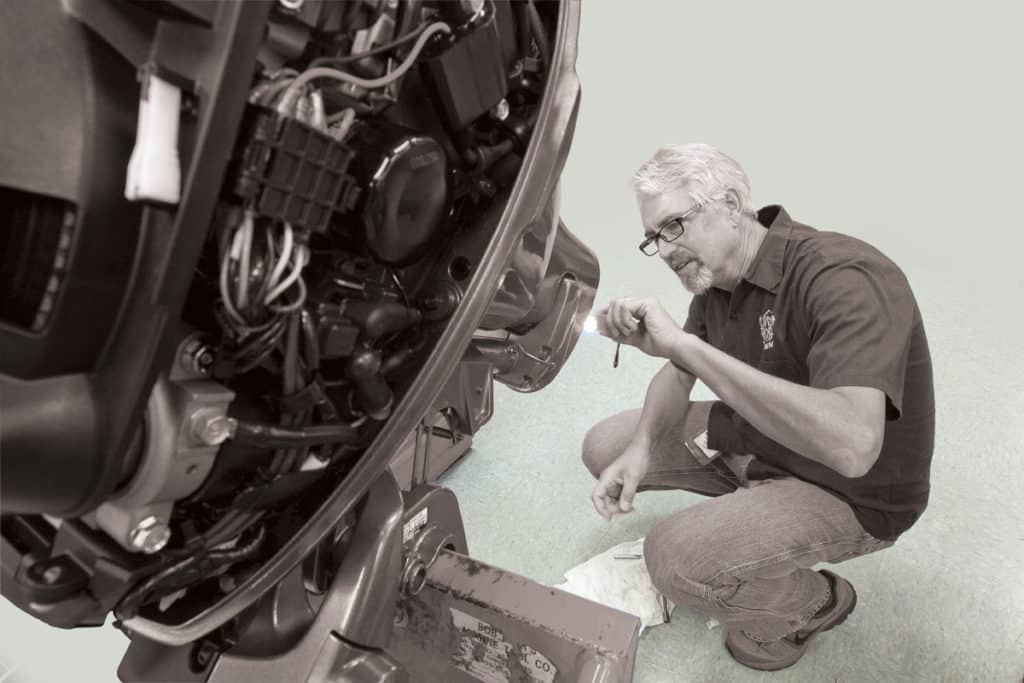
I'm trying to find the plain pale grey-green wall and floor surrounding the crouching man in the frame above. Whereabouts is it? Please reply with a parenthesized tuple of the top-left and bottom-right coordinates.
(0, 0, 1024, 683)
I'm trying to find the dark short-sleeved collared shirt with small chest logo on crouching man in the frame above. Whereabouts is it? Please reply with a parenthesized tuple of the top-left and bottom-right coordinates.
(684, 206, 935, 540)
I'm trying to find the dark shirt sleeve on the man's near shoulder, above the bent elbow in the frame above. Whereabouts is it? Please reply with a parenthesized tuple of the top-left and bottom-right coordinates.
(805, 255, 916, 419)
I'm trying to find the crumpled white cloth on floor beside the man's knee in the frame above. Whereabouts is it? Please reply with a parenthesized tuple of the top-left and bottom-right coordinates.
(555, 538, 675, 633)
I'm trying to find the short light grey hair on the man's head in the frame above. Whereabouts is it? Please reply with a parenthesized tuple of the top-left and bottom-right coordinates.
(633, 142, 756, 215)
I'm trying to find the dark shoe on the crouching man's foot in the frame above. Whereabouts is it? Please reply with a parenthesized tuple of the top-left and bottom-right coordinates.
(725, 569, 857, 671)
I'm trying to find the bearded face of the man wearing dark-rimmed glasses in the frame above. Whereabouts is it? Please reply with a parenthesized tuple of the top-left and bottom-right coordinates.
(639, 186, 736, 294)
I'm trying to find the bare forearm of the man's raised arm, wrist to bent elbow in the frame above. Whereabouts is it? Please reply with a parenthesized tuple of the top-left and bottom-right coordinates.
(667, 331, 886, 478)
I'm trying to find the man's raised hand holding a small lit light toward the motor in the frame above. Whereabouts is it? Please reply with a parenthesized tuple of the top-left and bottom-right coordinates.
(594, 297, 683, 358)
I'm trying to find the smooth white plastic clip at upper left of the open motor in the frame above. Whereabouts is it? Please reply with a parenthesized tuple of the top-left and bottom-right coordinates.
(125, 71, 181, 204)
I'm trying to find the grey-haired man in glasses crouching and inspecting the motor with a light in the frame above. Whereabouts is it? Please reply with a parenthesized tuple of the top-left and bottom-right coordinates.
(583, 143, 934, 671)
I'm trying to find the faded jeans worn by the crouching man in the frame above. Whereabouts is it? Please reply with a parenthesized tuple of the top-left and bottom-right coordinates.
(583, 401, 893, 642)
